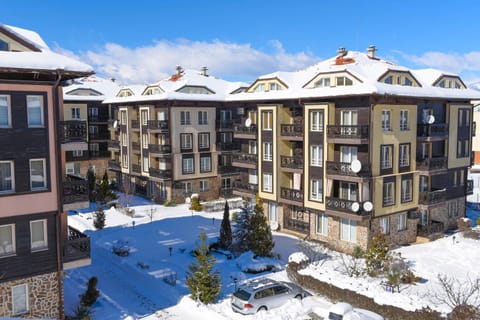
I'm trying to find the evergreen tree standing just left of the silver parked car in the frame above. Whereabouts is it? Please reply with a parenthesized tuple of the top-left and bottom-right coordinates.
(186, 230, 221, 304)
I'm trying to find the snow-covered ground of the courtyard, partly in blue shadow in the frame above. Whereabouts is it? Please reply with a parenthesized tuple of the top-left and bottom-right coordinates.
(65, 198, 480, 320)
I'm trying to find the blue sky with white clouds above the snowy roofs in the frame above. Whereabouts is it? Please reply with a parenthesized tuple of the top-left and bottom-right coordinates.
(0, 0, 480, 83)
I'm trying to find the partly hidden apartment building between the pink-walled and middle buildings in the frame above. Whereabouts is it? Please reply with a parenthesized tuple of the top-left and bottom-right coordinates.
(63, 75, 120, 178)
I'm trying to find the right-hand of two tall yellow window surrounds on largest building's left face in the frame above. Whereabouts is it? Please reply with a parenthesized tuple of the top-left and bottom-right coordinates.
(303, 103, 335, 211)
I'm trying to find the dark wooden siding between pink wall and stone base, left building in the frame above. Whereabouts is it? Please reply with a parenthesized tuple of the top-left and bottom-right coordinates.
(0, 212, 58, 281)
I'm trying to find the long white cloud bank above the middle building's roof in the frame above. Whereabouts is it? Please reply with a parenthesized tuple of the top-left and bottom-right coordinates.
(67, 39, 318, 84)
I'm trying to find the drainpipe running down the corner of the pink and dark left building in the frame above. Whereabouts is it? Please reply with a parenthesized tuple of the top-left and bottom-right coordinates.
(52, 69, 65, 319)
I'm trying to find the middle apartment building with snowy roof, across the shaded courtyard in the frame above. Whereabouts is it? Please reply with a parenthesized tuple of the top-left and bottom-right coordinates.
(104, 66, 248, 203)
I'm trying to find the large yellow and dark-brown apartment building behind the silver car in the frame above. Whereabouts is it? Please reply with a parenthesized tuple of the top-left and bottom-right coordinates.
(228, 46, 479, 252)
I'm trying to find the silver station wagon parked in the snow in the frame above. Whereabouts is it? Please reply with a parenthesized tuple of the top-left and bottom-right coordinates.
(231, 278, 305, 314)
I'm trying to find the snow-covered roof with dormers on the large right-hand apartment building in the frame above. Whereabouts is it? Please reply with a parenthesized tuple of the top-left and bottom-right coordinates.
(227, 51, 480, 101)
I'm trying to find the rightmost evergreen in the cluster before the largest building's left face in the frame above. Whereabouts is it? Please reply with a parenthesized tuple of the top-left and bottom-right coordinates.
(247, 194, 275, 257)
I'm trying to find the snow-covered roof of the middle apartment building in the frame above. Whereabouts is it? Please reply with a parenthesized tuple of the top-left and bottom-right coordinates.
(104, 70, 248, 103)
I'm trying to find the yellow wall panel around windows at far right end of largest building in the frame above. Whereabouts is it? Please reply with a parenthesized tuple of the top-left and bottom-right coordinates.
(447, 104, 473, 168)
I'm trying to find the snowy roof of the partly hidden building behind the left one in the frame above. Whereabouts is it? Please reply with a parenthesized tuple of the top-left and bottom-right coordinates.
(63, 75, 121, 101)
